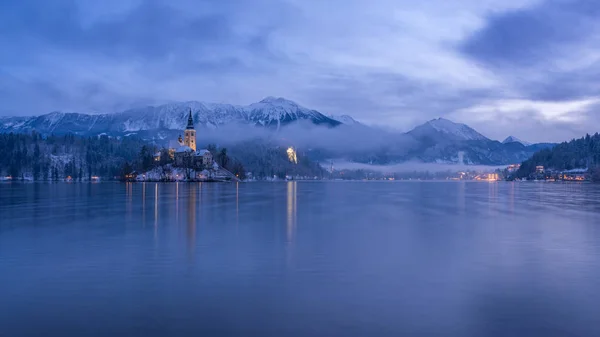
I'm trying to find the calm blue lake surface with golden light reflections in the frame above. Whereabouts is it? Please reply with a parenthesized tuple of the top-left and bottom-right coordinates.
(0, 182, 600, 337)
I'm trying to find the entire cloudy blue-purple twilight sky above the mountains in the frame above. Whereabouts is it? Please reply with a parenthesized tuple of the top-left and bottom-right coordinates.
(0, 0, 600, 141)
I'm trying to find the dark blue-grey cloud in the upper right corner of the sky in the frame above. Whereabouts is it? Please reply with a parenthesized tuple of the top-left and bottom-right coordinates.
(461, 0, 600, 101)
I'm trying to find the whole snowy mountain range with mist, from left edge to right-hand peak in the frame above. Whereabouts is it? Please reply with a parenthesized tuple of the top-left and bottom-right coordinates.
(0, 102, 552, 165)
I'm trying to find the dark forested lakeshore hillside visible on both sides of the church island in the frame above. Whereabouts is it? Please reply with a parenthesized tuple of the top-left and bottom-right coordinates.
(0, 132, 323, 181)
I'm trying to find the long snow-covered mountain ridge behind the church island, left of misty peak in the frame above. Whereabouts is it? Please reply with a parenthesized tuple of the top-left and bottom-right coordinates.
(0, 97, 340, 135)
